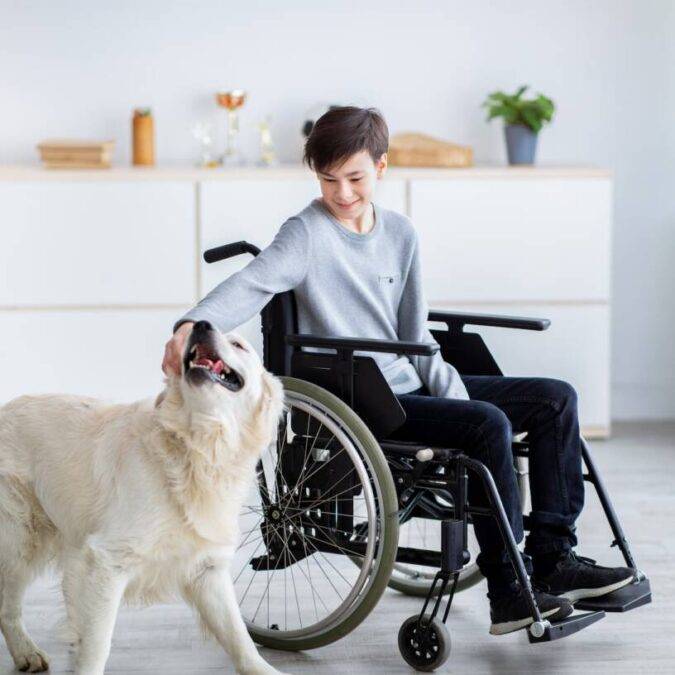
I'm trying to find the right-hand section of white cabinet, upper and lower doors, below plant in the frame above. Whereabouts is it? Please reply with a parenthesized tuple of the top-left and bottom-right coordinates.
(410, 176, 611, 436)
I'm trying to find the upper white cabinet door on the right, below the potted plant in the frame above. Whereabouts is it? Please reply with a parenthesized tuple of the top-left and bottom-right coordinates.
(411, 177, 611, 302)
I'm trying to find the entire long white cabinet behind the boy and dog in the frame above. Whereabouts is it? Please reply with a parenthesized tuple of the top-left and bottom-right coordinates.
(0, 167, 611, 435)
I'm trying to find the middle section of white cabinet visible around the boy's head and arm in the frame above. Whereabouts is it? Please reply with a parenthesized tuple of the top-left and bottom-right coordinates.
(200, 177, 405, 353)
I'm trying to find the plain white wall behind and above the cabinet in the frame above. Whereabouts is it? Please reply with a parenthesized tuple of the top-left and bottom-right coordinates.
(0, 0, 675, 419)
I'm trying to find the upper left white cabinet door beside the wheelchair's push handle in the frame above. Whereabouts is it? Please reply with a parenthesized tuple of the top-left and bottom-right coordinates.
(0, 181, 196, 307)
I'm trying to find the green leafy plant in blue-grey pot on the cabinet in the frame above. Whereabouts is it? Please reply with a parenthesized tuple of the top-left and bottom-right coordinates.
(483, 85, 555, 164)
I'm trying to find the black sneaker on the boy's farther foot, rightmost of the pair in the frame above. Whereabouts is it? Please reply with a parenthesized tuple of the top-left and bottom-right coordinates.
(532, 551, 635, 603)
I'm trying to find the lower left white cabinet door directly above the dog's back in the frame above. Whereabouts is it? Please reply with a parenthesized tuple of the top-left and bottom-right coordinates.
(0, 306, 187, 404)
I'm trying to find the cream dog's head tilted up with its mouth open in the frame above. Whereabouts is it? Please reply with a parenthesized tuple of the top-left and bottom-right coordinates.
(158, 321, 284, 449)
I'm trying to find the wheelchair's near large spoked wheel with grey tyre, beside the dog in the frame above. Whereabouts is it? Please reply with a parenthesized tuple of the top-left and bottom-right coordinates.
(231, 377, 398, 650)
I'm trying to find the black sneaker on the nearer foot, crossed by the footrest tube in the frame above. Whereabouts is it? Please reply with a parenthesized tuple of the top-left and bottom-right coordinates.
(488, 584, 574, 635)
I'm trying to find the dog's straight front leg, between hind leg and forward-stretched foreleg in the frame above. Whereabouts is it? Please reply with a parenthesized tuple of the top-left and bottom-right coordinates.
(71, 552, 128, 675)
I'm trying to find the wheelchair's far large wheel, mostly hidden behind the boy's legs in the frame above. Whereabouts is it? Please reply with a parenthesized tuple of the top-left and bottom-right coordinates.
(388, 457, 529, 598)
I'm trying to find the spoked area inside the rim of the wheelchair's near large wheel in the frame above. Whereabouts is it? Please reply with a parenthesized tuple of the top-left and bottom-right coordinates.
(233, 394, 381, 634)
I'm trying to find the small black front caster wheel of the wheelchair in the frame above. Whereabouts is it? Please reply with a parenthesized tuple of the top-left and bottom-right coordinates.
(398, 614, 450, 672)
